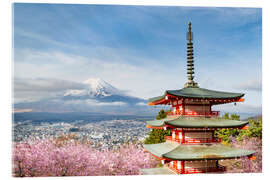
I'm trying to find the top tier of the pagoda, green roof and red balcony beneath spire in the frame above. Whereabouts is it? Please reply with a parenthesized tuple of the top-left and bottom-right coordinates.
(148, 87, 244, 117)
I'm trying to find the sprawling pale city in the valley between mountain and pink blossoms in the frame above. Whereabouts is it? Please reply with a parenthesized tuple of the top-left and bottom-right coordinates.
(13, 114, 150, 150)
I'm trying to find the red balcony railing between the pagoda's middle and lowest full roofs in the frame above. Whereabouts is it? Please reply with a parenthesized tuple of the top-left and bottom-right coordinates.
(165, 136, 221, 144)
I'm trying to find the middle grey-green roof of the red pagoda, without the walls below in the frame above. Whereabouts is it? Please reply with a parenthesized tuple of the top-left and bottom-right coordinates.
(146, 116, 248, 128)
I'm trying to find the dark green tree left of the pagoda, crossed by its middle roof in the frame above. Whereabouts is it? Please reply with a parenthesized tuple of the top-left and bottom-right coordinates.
(144, 109, 170, 144)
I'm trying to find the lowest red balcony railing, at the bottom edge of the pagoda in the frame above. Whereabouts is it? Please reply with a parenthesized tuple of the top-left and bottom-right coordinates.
(169, 165, 226, 174)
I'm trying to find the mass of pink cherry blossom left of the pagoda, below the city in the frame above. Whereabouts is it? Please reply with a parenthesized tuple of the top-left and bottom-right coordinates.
(13, 139, 158, 177)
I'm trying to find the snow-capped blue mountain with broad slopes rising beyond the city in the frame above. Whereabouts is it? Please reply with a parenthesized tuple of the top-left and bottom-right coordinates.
(14, 78, 149, 114)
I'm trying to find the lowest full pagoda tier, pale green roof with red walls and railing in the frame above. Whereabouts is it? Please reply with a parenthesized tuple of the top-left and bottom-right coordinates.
(141, 141, 255, 174)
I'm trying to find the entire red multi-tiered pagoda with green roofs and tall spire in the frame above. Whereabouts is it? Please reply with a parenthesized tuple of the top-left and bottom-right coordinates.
(141, 22, 255, 174)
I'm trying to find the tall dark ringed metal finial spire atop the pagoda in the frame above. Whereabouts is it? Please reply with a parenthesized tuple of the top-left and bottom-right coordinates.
(185, 22, 198, 87)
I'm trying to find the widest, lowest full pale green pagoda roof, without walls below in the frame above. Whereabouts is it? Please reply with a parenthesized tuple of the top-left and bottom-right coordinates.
(144, 142, 255, 161)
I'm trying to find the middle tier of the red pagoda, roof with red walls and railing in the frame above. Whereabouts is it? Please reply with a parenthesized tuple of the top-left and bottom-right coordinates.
(146, 116, 248, 144)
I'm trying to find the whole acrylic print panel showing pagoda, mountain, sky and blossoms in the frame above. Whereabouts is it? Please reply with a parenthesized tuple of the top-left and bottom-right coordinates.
(12, 3, 262, 177)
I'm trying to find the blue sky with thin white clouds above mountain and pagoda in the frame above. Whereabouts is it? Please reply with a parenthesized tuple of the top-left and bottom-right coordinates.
(13, 4, 262, 113)
